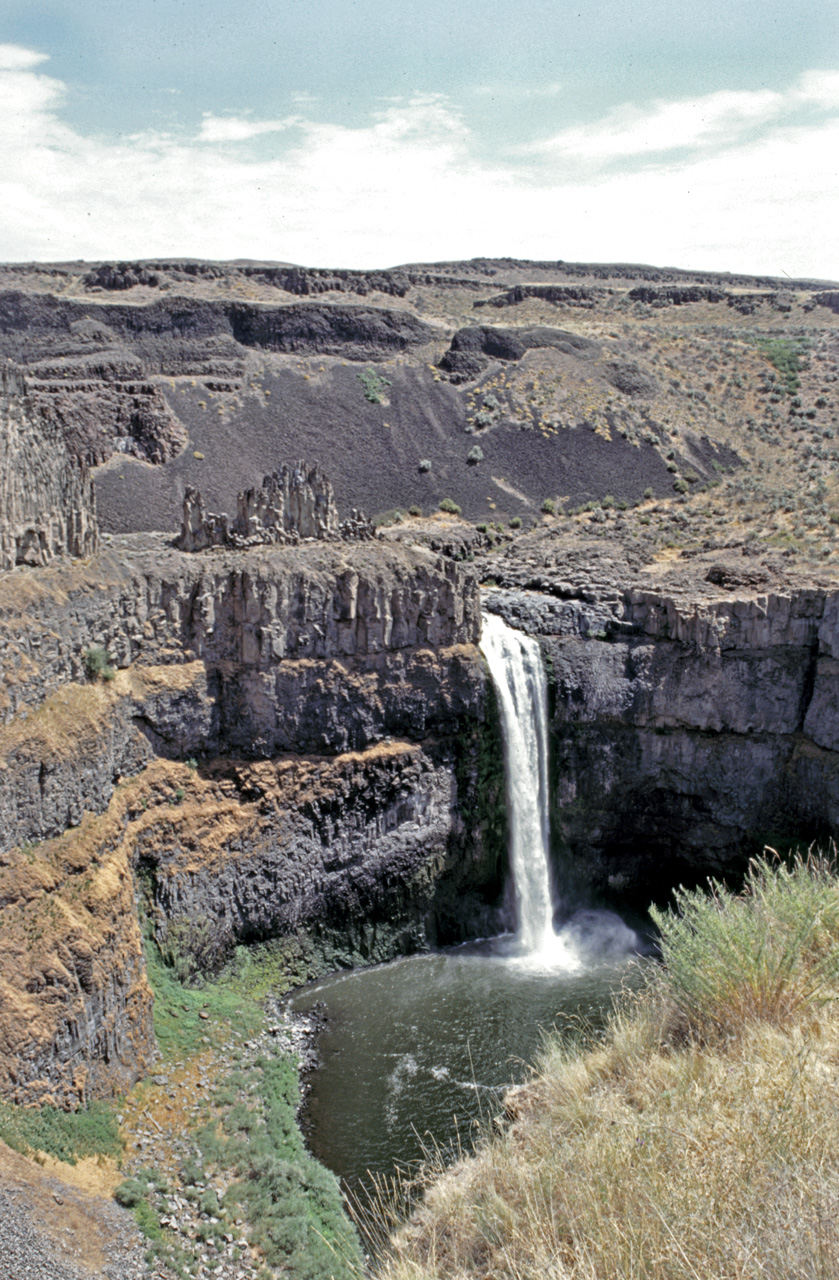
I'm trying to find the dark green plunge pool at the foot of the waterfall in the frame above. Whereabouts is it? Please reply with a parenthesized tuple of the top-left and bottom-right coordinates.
(292, 931, 639, 1188)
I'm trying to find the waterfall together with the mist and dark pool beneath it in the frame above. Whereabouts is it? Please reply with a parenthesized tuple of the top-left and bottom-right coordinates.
(292, 614, 643, 1190)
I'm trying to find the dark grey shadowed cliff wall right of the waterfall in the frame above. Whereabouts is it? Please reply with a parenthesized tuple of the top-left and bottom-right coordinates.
(488, 584, 839, 908)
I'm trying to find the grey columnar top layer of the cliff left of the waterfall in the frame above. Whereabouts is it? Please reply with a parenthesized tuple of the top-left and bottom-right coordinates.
(0, 534, 480, 732)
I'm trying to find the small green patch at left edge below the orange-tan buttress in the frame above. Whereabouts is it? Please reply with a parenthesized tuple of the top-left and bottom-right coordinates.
(0, 1101, 122, 1165)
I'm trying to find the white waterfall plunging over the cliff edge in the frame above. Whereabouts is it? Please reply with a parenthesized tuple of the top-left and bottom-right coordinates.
(480, 613, 579, 968)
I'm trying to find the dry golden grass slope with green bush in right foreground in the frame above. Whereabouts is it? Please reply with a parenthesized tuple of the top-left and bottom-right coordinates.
(380, 858, 839, 1280)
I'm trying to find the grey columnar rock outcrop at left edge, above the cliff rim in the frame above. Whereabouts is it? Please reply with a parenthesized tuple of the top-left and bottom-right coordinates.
(0, 355, 99, 570)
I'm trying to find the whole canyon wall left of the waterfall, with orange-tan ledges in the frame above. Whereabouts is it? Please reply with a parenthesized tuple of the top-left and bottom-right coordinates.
(0, 535, 506, 1103)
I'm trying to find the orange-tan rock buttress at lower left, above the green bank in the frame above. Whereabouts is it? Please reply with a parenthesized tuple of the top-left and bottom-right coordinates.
(0, 819, 154, 1106)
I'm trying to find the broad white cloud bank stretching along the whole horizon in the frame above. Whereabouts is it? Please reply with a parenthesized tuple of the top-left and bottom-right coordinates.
(0, 46, 839, 276)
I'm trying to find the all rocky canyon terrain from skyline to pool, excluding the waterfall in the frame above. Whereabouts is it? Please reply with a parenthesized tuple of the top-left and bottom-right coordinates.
(0, 254, 839, 1106)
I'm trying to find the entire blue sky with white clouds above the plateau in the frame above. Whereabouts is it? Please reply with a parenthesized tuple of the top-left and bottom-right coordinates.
(0, 0, 839, 279)
